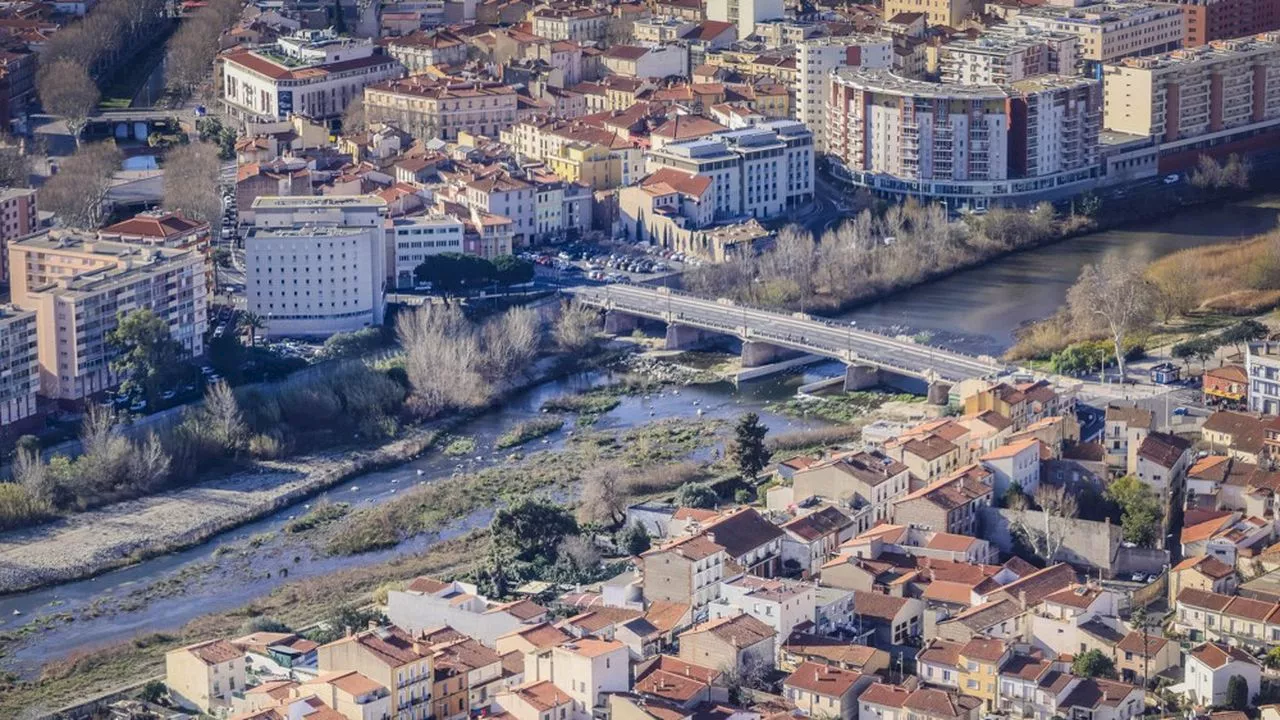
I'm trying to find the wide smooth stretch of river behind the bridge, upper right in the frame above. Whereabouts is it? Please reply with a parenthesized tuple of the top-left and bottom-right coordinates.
(844, 195, 1280, 355)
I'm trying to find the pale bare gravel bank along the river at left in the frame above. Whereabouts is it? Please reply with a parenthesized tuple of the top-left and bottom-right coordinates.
(0, 428, 436, 594)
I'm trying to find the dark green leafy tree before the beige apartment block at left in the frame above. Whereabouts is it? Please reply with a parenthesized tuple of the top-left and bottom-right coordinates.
(106, 307, 184, 401)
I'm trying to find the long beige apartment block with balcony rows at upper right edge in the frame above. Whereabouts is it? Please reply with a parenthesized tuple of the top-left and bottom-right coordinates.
(1103, 33, 1280, 148)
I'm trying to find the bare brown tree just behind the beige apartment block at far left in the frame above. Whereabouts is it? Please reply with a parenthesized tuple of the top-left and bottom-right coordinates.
(40, 141, 120, 229)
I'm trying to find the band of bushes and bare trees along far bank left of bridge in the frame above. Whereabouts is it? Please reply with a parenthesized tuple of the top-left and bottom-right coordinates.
(0, 299, 598, 540)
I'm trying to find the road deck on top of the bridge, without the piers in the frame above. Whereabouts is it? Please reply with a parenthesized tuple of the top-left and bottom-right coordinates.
(563, 284, 1009, 383)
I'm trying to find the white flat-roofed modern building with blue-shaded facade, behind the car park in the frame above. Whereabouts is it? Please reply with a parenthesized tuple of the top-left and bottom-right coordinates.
(645, 120, 814, 220)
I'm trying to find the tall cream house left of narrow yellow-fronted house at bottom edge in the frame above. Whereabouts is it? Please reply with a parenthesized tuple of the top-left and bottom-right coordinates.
(316, 625, 434, 720)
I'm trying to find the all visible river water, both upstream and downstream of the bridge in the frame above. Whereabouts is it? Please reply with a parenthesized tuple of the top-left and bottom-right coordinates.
(0, 196, 1280, 675)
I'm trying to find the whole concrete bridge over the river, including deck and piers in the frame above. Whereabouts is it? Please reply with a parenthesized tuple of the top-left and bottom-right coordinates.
(564, 284, 1011, 404)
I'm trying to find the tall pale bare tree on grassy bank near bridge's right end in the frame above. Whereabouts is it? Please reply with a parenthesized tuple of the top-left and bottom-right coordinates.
(1066, 259, 1155, 380)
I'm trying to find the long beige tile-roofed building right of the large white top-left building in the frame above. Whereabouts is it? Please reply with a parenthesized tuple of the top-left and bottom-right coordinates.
(365, 76, 516, 141)
